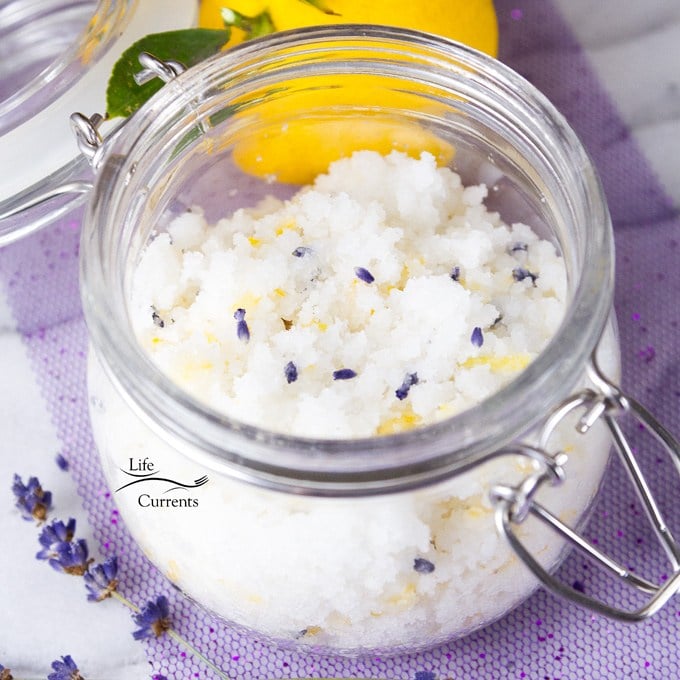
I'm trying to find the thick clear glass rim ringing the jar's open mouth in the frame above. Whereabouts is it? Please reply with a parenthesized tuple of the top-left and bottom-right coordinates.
(81, 25, 614, 496)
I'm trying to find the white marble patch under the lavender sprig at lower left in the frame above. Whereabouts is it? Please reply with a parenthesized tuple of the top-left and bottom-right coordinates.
(0, 298, 150, 680)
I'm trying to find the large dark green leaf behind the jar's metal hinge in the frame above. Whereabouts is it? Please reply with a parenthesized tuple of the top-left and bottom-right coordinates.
(106, 28, 230, 118)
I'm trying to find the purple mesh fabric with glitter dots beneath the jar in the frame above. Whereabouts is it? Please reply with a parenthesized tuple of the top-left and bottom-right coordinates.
(0, 0, 680, 680)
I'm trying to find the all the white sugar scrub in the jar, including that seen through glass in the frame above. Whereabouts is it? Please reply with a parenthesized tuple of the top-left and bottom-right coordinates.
(89, 152, 616, 654)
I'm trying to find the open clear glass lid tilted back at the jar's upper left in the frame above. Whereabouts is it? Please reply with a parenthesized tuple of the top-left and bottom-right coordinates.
(0, 0, 196, 245)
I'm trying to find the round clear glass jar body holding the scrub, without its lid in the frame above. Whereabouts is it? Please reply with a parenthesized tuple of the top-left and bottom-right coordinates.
(77, 26, 676, 654)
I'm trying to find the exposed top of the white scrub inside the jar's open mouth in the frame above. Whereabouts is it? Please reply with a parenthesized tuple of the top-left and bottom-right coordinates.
(131, 152, 566, 438)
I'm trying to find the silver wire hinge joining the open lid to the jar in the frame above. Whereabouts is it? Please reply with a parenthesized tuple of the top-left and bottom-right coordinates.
(0, 52, 186, 224)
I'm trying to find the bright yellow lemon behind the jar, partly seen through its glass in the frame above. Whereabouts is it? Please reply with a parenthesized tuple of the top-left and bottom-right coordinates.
(199, 0, 498, 184)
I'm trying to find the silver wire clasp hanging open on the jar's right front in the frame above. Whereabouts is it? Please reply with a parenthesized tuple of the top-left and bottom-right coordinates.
(490, 356, 680, 621)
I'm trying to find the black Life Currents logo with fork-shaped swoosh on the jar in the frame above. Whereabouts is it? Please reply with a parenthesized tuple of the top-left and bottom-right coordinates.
(116, 456, 208, 508)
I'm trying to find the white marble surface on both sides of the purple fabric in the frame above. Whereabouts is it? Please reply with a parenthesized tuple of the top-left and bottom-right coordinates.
(0, 0, 680, 680)
